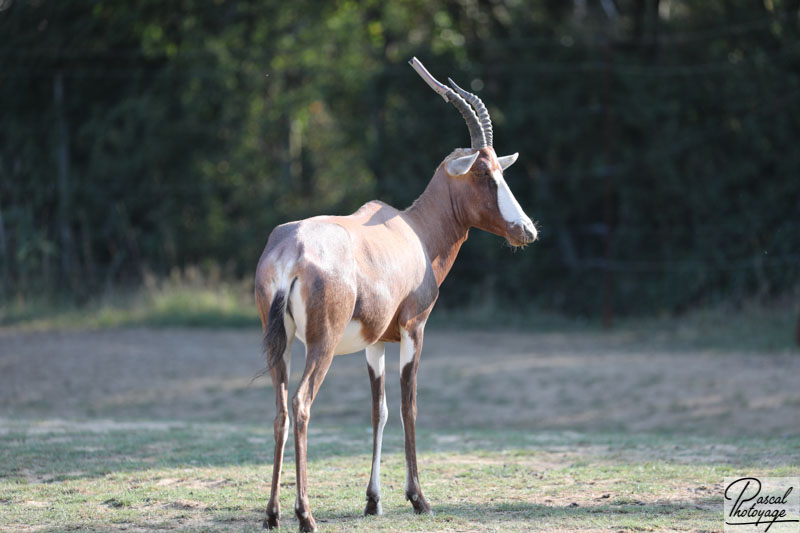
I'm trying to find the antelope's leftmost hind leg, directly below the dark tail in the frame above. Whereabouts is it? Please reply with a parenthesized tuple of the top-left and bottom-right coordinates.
(264, 317, 295, 529)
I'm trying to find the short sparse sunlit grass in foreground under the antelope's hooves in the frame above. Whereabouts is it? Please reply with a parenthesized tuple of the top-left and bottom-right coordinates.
(0, 420, 800, 531)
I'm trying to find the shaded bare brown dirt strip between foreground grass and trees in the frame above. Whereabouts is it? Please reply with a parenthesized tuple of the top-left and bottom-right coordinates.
(0, 328, 800, 436)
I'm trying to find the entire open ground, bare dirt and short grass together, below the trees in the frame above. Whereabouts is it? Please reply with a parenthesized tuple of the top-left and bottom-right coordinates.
(0, 308, 800, 531)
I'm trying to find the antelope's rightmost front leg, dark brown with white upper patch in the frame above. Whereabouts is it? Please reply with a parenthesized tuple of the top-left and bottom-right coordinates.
(400, 326, 431, 514)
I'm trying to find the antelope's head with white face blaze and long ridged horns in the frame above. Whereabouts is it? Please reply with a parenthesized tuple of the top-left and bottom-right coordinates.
(409, 57, 537, 246)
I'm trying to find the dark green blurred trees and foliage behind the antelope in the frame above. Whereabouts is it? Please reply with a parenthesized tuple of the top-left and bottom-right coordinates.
(0, 0, 800, 314)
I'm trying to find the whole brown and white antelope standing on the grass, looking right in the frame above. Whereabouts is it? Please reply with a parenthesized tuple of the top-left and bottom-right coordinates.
(255, 57, 537, 531)
